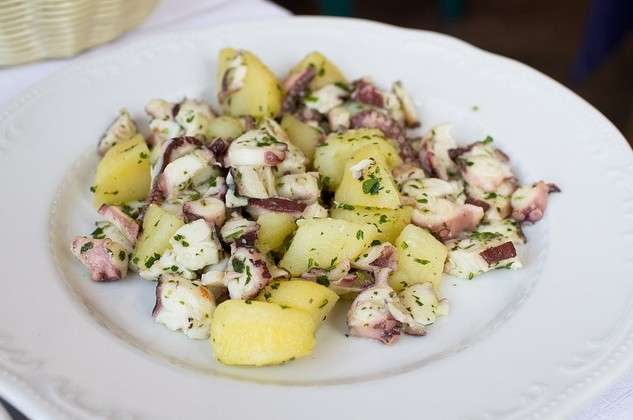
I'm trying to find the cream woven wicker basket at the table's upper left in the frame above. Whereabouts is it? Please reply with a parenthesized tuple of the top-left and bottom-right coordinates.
(0, 0, 158, 66)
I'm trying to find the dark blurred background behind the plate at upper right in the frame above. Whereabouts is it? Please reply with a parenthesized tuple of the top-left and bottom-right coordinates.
(275, 0, 633, 144)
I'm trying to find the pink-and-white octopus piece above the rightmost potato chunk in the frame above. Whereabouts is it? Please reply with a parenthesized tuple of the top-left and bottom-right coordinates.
(411, 198, 484, 241)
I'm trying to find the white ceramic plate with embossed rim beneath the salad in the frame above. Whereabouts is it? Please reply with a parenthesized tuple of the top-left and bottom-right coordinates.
(0, 18, 633, 420)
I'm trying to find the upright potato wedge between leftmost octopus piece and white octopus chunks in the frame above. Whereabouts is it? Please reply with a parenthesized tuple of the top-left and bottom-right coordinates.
(131, 204, 184, 270)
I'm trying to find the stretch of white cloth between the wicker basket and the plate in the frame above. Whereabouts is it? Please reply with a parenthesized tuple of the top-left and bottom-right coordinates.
(0, 0, 290, 108)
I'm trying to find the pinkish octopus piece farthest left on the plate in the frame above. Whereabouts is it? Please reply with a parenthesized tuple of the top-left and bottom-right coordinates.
(70, 236, 129, 281)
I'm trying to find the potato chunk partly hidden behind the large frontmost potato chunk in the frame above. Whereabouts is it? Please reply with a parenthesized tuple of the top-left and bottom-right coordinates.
(257, 279, 338, 327)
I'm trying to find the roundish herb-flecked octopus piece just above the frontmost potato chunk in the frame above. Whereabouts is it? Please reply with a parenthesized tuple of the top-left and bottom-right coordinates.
(225, 247, 272, 299)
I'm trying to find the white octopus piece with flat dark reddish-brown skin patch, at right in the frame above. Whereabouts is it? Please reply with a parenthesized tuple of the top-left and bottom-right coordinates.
(444, 231, 522, 279)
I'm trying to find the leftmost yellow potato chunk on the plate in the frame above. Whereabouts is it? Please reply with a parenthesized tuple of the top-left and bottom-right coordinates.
(92, 134, 151, 208)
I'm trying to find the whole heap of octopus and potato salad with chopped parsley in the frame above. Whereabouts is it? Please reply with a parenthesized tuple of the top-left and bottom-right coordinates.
(71, 48, 559, 366)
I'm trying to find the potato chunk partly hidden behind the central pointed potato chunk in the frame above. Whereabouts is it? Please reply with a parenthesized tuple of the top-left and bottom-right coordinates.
(314, 128, 402, 191)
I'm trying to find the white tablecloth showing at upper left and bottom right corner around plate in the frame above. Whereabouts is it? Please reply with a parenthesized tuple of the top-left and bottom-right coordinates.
(0, 0, 633, 420)
